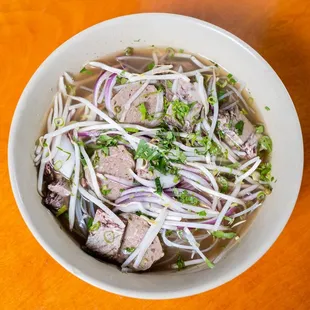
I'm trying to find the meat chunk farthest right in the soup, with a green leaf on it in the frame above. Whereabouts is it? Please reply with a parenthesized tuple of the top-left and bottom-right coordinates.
(218, 106, 258, 158)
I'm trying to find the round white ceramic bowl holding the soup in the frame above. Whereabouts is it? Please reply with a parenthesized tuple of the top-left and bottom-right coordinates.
(9, 14, 303, 299)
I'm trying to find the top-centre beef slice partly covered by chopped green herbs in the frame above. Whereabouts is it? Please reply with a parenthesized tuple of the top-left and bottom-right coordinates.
(164, 79, 203, 132)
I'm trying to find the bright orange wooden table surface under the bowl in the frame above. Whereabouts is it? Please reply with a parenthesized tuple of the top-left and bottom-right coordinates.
(0, 0, 310, 310)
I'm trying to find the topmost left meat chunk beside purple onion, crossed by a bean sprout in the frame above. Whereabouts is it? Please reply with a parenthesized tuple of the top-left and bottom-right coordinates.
(111, 83, 160, 127)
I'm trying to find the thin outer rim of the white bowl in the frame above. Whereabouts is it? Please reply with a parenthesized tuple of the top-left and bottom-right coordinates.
(8, 13, 304, 299)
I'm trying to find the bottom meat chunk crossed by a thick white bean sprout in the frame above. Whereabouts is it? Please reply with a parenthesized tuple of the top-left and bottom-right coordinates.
(117, 213, 164, 270)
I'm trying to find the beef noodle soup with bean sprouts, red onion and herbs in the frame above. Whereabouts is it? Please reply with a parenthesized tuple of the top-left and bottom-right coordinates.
(34, 47, 273, 272)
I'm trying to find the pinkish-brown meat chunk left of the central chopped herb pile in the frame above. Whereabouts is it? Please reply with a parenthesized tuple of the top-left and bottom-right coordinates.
(84, 145, 135, 200)
